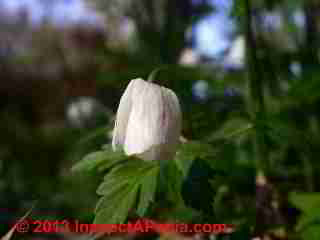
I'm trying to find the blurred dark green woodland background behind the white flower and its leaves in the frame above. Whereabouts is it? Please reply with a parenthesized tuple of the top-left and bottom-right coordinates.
(0, 0, 320, 240)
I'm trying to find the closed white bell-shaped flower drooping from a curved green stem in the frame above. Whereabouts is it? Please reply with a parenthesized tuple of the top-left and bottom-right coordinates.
(112, 79, 182, 160)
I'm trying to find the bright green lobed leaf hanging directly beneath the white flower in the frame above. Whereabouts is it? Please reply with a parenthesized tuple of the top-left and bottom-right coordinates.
(94, 157, 159, 224)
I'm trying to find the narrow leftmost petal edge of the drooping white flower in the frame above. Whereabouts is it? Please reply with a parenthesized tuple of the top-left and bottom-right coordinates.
(112, 80, 135, 150)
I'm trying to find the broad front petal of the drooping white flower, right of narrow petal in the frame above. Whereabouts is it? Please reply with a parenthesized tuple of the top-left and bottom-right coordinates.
(124, 80, 181, 160)
